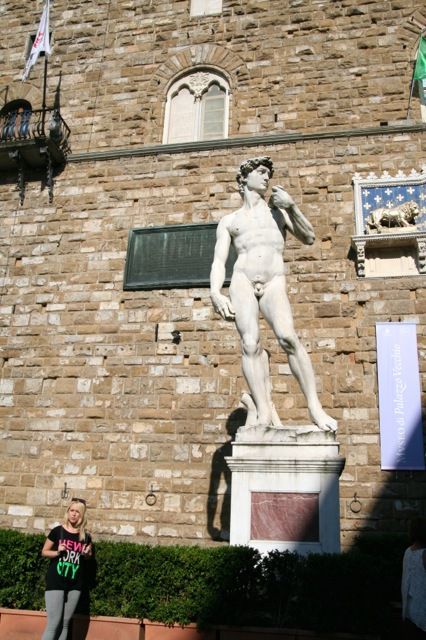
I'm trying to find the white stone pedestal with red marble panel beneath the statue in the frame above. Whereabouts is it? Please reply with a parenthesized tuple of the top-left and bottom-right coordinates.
(226, 426, 345, 553)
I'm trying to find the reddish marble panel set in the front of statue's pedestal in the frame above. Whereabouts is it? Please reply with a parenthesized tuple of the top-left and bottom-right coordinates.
(250, 491, 319, 542)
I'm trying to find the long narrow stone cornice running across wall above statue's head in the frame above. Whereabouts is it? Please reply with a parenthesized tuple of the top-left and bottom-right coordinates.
(67, 122, 426, 162)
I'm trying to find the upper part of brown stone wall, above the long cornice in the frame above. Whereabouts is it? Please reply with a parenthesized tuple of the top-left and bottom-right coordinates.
(0, 0, 426, 146)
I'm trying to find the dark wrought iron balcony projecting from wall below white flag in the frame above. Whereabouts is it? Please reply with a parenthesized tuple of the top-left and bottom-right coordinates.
(0, 106, 70, 204)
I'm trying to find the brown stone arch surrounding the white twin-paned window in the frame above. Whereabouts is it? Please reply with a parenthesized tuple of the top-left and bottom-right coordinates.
(145, 44, 249, 143)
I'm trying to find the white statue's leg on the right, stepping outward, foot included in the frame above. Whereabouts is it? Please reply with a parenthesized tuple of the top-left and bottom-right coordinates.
(260, 276, 337, 431)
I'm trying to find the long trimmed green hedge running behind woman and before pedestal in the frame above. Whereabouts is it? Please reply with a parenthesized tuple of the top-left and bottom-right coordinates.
(0, 530, 406, 637)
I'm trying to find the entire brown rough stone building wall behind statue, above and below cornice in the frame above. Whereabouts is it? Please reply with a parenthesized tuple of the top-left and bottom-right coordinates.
(0, 0, 426, 545)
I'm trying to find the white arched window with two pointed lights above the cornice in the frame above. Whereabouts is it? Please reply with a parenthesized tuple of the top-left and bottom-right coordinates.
(163, 71, 229, 144)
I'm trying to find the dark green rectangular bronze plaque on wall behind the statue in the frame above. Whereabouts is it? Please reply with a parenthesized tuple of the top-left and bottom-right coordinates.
(124, 223, 236, 290)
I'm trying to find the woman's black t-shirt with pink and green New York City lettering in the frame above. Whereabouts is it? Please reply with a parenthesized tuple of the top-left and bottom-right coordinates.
(46, 526, 91, 591)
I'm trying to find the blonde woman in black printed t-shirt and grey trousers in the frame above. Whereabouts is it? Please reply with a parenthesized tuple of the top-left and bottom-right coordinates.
(41, 498, 92, 640)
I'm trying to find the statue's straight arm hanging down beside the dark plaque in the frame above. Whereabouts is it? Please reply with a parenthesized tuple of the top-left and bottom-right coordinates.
(210, 216, 235, 320)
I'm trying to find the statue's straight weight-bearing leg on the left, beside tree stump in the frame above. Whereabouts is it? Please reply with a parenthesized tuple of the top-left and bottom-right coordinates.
(229, 273, 272, 426)
